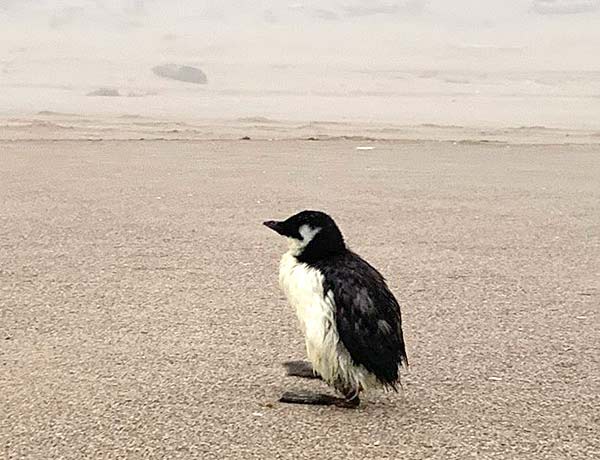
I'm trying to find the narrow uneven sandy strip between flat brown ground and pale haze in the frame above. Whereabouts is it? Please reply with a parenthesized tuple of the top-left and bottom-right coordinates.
(0, 111, 600, 145)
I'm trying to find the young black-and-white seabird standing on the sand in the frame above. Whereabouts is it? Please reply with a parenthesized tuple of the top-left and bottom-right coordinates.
(263, 210, 408, 408)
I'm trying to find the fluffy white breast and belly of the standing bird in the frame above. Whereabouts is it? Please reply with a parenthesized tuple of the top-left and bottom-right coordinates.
(279, 252, 373, 389)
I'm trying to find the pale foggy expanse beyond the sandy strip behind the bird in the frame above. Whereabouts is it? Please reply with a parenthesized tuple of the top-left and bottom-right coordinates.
(0, 0, 600, 128)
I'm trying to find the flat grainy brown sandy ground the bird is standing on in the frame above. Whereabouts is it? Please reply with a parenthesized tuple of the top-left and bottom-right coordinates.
(0, 135, 600, 460)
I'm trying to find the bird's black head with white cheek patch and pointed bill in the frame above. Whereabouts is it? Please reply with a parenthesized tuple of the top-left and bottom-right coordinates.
(264, 211, 346, 262)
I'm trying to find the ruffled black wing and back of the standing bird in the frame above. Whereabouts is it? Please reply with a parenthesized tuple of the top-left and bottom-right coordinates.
(319, 251, 408, 389)
